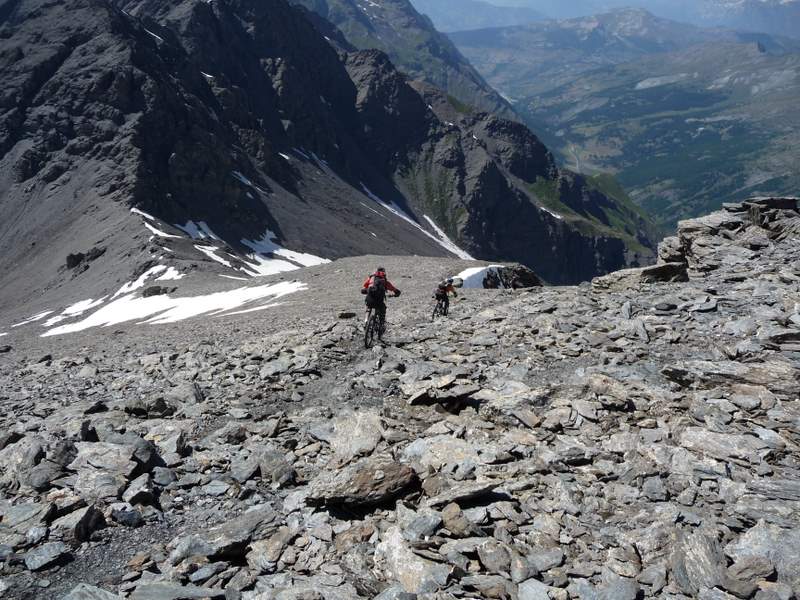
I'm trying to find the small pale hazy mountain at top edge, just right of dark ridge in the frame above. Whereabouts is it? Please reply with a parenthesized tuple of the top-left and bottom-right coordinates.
(411, 0, 546, 32)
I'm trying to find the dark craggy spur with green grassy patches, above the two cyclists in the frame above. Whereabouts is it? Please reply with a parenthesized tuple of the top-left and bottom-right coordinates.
(348, 51, 657, 281)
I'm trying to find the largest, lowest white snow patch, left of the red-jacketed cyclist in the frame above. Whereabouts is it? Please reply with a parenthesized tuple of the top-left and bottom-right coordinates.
(42, 281, 308, 337)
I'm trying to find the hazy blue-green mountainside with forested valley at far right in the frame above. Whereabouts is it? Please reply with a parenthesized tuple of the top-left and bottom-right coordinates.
(451, 9, 800, 227)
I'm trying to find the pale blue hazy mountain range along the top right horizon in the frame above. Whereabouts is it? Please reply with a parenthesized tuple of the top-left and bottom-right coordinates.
(487, 0, 800, 37)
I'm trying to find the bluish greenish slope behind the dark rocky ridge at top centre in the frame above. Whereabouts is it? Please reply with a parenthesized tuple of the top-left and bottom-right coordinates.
(291, 0, 516, 119)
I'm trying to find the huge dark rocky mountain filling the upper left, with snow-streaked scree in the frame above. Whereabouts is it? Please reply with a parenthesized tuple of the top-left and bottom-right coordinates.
(0, 0, 652, 303)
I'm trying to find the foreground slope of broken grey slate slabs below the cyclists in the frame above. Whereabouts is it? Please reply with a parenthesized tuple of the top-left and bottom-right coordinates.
(0, 198, 800, 600)
